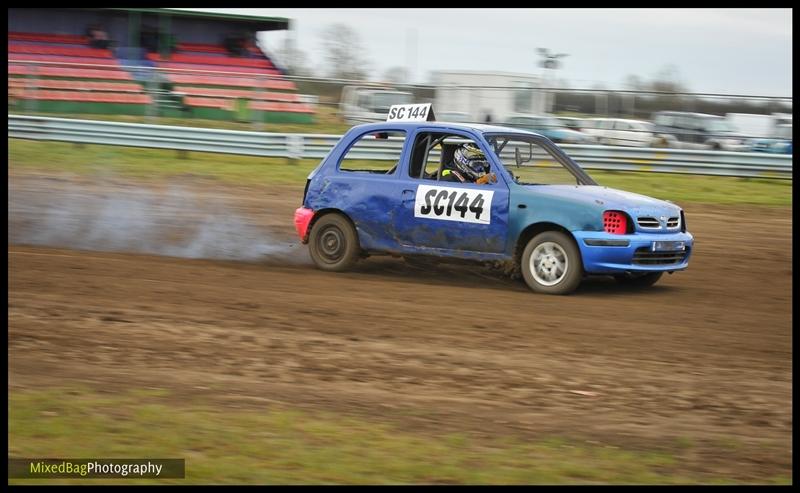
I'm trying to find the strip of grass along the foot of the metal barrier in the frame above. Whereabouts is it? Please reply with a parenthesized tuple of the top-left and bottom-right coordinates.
(8, 139, 792, 206)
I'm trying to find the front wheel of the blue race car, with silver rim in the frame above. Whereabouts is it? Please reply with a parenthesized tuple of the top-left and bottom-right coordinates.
(520, 231, 583, 294)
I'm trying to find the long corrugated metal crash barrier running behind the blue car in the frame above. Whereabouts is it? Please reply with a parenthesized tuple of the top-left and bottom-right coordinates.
(8, 115, 792, 179)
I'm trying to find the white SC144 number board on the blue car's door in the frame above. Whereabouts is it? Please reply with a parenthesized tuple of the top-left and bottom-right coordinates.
(414, 185, 494, 224)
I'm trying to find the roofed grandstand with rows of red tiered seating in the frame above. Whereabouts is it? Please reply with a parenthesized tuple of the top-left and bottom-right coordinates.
(8, 8, 314, 122)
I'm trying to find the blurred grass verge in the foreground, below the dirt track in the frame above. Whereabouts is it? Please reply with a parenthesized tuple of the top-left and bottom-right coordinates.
(8, 387, 786, 484)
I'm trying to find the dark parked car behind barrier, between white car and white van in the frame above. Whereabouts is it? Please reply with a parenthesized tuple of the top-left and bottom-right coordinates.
(653, 111, 749, 151)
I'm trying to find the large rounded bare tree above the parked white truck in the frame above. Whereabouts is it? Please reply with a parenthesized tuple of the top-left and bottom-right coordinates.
(322, 24, 371, 79)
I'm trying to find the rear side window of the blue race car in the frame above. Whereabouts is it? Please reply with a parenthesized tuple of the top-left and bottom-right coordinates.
(339, 130, 406, 175)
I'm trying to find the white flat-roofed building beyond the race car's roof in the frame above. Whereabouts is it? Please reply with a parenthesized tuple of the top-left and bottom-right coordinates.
(431, 70, 545, 123)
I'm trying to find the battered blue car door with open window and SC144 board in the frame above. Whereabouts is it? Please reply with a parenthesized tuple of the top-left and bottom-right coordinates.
(393, 129, 509, 256)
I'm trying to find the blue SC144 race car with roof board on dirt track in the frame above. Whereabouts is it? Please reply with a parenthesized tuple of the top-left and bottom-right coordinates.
(294, 105, 693, 294)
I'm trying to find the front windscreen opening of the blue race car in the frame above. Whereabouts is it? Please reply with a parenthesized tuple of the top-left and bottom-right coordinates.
(486, 133, 596, 185)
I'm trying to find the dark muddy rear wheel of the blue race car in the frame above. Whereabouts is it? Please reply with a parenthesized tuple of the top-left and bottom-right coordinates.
(308, 213, 361, 272)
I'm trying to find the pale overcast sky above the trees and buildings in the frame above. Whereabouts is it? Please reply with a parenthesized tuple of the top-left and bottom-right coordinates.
(172, 8, 792, 97)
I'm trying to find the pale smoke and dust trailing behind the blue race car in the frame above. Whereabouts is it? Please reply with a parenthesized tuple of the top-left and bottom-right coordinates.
(8, 178, 308, 263)
